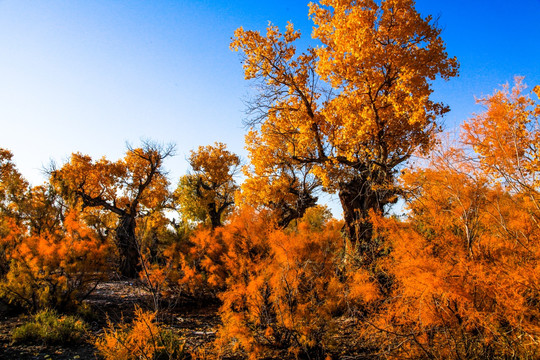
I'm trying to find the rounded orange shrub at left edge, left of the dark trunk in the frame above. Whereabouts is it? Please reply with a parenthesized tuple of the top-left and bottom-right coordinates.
(0, 212, 109, 310)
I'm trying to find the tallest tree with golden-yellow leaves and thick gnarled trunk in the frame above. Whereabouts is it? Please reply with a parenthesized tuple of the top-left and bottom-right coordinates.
(231, 0, 458, 242)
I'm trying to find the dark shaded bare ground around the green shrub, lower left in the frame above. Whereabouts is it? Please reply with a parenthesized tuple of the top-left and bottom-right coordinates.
(0, 281, 220, 360)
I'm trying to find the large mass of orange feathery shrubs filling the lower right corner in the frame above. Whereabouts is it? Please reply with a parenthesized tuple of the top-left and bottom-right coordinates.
(375, 163, 540, 359)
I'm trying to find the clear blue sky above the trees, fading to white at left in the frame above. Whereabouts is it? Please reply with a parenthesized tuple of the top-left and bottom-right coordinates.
(0, 0, 540, 214)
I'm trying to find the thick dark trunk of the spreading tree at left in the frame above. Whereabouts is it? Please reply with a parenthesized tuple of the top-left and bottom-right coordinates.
(116, 214, 142, 279)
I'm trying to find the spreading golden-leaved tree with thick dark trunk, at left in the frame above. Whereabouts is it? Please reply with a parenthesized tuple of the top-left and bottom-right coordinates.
(51, 142, 174, 278)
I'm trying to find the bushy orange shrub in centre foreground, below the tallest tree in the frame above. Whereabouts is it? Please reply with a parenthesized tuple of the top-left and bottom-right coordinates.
(213, 210, 379, 359)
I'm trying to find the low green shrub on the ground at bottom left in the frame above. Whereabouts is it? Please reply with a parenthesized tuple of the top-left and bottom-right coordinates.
(11, 310, 87, 345)
